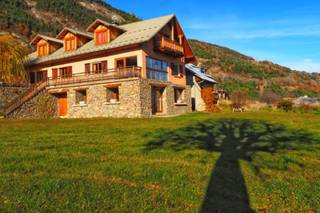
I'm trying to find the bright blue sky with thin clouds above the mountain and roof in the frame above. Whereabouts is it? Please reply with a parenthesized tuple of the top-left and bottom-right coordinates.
(106, 0, 320, 72)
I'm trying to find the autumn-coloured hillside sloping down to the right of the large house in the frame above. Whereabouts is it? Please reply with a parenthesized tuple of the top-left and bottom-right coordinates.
(189, 40, 320, 98)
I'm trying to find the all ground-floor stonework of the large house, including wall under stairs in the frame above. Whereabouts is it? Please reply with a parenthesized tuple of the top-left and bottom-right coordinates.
(5, 79, 191, 118)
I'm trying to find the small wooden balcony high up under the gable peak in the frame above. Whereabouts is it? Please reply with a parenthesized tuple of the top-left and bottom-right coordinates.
(156, 36, 184, 57)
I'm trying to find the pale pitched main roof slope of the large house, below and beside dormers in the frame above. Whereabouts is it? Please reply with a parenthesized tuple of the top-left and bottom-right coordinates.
(29, 15, 175, 65)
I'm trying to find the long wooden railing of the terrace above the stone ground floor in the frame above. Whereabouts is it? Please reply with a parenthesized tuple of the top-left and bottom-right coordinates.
(47, 66, 142, 86)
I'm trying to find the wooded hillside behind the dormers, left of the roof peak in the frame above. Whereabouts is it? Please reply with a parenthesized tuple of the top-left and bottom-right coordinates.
(0, 0, 139, 40)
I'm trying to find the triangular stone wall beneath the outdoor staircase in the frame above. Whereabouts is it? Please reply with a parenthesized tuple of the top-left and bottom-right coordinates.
(8, 90, 58, 119)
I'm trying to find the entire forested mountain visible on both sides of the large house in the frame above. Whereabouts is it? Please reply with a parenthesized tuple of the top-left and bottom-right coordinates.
(0, 0, 320, 99)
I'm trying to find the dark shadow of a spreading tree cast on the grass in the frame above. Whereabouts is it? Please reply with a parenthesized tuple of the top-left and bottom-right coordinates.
(146, 119, 319, 213)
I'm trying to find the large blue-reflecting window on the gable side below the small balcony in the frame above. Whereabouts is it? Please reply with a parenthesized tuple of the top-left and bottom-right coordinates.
(147, 57, 168, 81)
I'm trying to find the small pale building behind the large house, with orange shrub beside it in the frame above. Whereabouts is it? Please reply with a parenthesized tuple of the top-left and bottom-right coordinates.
(186, 63, 218, 112)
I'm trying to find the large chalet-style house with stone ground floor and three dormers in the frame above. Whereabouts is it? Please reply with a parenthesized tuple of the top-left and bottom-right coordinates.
(6, 15, 194, 118)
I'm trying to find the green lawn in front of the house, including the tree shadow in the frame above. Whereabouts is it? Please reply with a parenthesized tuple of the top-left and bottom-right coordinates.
(0, 112, 320, 212)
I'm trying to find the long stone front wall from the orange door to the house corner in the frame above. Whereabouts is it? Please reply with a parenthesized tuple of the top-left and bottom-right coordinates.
(66, 79, 151, 118)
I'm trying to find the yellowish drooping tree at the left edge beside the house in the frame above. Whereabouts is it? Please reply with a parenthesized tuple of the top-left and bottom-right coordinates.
(0, 34, 28, 82)
